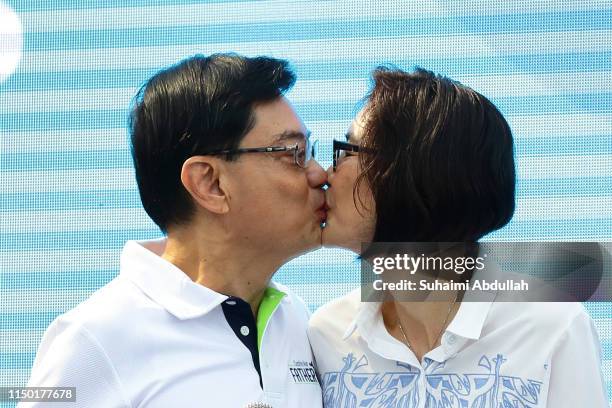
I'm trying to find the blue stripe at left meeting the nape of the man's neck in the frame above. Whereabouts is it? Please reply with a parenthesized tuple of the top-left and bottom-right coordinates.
(0, 230, 163, 251)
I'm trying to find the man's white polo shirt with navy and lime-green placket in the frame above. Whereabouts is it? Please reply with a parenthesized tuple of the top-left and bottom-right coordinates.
(19, 242, 321, 408)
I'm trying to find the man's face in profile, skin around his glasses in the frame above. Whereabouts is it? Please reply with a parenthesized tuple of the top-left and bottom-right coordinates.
(225, 97, 327, 259)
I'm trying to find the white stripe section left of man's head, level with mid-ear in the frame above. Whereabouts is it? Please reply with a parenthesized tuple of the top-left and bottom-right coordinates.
(0, 167, 137, 193)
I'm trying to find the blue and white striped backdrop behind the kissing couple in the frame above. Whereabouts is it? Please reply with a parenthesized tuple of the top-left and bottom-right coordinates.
(0, 0, 612, 405)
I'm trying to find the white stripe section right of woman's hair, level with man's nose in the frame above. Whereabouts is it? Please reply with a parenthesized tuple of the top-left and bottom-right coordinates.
(517, 155, 612, 180)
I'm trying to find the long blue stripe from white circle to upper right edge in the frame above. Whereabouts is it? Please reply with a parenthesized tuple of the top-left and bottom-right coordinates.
(25, 9, 612, 52)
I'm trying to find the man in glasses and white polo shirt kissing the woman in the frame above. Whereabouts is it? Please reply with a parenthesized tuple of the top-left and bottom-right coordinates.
(24, 54, 326, 408)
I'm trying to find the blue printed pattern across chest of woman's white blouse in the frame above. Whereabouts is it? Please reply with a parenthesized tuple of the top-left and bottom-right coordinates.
(322, 353, 542, 408)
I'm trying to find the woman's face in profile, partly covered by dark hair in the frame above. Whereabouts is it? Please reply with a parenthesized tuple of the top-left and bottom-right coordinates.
(322, 110, 376, 253)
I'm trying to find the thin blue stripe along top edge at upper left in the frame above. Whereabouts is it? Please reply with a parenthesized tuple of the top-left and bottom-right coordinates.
(4, 0, 252, 12)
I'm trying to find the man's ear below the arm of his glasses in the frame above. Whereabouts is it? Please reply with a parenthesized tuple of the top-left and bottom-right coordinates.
(181, 156, 229, 214)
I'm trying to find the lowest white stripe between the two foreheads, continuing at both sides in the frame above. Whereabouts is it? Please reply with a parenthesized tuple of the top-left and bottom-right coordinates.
(0, 115, 612, 153)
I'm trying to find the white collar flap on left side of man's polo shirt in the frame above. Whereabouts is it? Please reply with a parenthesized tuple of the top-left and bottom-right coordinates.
(120, 241, 234, 320)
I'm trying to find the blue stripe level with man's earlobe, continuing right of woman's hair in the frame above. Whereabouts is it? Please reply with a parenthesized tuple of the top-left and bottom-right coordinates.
(0, 177, 612, 211)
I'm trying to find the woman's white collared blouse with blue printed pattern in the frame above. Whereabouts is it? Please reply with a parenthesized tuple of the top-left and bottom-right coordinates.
(309, 290, 608, 408)
